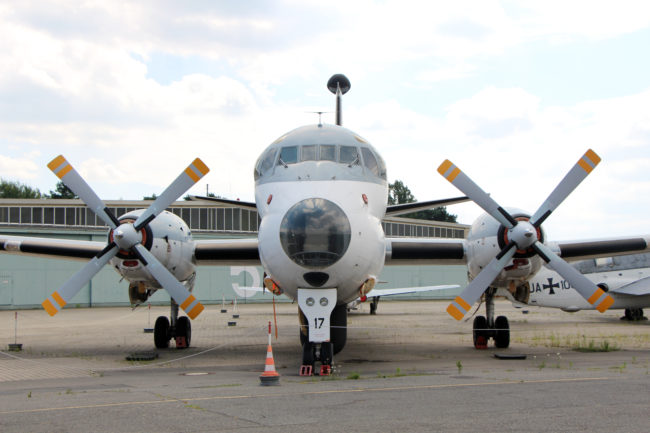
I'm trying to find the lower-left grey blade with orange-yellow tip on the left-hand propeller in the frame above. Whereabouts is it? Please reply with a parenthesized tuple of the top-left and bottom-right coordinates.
(41, 243, 120, 316)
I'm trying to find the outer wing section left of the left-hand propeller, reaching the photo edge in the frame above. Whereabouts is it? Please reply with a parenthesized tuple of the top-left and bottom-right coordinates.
(0, 234, 106, 261)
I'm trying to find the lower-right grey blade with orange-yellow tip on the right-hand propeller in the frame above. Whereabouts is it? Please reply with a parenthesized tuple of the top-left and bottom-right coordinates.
(533, 242, 614, 313)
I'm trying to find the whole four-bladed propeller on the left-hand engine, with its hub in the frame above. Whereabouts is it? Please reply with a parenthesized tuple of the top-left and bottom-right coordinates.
(42, 155, 210, 319)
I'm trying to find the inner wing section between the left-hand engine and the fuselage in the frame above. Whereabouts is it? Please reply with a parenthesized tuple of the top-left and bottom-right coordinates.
(194, 238, 261, 266)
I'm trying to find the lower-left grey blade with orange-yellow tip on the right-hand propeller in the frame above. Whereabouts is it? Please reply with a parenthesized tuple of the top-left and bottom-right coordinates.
(447, 243, 517, 320)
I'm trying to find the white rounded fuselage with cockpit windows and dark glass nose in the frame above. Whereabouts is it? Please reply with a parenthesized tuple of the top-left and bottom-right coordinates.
(255, 125, 388, 304)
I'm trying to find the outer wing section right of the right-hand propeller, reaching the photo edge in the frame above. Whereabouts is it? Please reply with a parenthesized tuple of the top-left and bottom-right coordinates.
(548, 235, 650, 261)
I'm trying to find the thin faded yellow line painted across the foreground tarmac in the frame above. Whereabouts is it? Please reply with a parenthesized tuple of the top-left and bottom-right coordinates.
(0, 377, 614, 415)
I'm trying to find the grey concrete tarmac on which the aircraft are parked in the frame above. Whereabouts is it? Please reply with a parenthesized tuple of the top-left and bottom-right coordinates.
(0, 300, 650, 433)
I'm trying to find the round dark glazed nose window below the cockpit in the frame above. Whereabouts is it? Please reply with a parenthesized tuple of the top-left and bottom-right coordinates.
(280, 198, 351, 266)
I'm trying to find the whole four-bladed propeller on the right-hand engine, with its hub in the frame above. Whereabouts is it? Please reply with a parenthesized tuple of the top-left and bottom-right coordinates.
(438, 149, 614, 320)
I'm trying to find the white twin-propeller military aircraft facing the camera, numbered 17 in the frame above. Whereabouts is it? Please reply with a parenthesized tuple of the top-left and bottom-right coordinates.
(0, 74, 650, 375)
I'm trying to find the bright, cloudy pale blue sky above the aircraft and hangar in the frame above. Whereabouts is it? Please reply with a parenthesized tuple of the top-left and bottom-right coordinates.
(0, 0, 650, 240)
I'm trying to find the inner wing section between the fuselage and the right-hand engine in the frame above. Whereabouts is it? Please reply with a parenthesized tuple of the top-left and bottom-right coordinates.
(386, 238, 467, 265)
